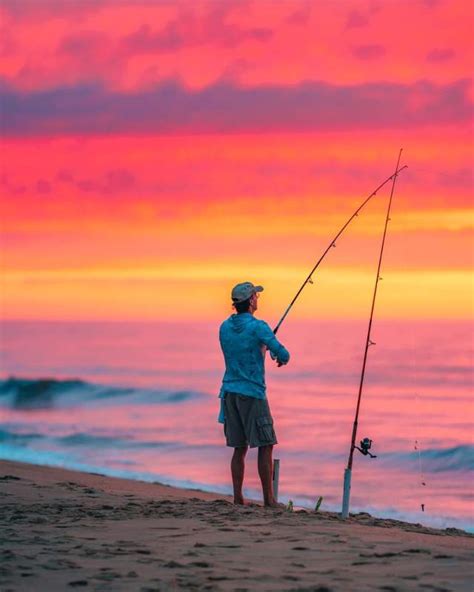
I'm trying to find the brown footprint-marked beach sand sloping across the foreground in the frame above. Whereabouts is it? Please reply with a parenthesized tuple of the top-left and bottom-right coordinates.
(0, 461, 474, 592)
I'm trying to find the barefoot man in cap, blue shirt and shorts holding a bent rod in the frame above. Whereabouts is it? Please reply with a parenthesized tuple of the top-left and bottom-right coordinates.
(219, 282, 290, 507)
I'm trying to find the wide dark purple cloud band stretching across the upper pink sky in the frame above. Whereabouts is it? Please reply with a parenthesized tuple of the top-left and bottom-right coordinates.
(0, 80, 472, 136)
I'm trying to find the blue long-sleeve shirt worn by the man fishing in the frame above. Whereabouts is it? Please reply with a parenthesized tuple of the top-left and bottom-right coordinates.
(219, 313, 290, 422)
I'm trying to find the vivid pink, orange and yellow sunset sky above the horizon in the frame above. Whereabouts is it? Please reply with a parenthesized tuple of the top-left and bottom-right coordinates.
(0, 0, 474, 321)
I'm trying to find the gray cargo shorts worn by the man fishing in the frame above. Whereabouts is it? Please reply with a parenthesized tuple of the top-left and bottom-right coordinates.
(224, 392, 277, 448)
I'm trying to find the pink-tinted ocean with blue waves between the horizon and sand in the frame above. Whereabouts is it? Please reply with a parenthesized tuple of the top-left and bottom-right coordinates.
(0, 319, 474, 532)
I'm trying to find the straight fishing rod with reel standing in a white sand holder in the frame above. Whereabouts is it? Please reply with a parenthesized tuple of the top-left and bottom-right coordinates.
(341, 148, 405, 518)
